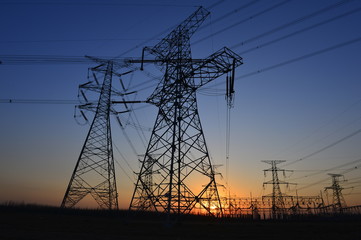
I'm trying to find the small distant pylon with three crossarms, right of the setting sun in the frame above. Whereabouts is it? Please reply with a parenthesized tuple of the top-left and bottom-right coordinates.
(262, 160, 293, 219)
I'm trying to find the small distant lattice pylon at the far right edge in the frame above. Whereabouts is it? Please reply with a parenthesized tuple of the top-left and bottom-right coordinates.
(325, 173, 346, 213)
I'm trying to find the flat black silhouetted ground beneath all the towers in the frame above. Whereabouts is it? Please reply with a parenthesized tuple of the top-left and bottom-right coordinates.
(0, 205, 361, 240)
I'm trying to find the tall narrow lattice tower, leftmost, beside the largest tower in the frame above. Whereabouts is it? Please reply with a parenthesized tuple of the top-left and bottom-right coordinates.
(61, 61, 118, 209)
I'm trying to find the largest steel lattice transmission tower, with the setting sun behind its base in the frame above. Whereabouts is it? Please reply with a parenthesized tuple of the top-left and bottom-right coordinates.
(129, 7, 242, 216)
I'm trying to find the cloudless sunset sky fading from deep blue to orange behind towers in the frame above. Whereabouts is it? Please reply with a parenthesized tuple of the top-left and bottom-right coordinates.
(0, 0, 361, 208)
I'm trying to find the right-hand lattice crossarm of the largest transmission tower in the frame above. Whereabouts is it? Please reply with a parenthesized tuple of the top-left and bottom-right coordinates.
(187, 47, 243, 88)
